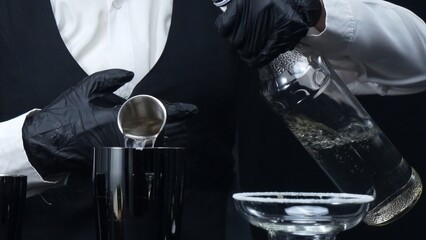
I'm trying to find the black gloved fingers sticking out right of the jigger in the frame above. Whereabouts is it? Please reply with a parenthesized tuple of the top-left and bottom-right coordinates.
(160, 101, 198, 147)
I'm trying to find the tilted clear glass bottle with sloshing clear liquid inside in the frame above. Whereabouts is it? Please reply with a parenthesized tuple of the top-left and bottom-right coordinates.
(259, 47, 422, 225)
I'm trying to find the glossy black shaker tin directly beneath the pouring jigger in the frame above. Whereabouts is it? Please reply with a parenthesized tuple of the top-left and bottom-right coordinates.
(93, 148, 185, 240)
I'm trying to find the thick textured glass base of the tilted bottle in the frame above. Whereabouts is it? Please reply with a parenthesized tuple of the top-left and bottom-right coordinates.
(363, 169, 423, 226)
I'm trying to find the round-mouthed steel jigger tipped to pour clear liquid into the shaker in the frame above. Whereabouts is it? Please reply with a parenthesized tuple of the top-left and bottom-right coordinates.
(117, 95, 167, 144)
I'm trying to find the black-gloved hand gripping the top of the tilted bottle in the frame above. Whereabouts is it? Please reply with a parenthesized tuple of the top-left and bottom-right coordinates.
(216, 0, 322, 67)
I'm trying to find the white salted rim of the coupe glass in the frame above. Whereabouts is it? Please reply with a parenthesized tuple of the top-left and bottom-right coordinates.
(232, 192, 374, 204)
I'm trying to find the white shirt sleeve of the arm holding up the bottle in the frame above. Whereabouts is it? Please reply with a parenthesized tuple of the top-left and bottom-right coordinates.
(302, 0, 426, 95)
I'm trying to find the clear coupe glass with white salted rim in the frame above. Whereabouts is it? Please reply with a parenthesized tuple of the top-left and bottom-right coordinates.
(233, 192, 374, 240)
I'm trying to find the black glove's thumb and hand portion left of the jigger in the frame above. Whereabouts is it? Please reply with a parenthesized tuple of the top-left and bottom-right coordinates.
(22, 69, 134, 177)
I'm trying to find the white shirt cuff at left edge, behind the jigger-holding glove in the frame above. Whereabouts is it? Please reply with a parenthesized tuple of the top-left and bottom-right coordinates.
(0, 110, 67, 196)
